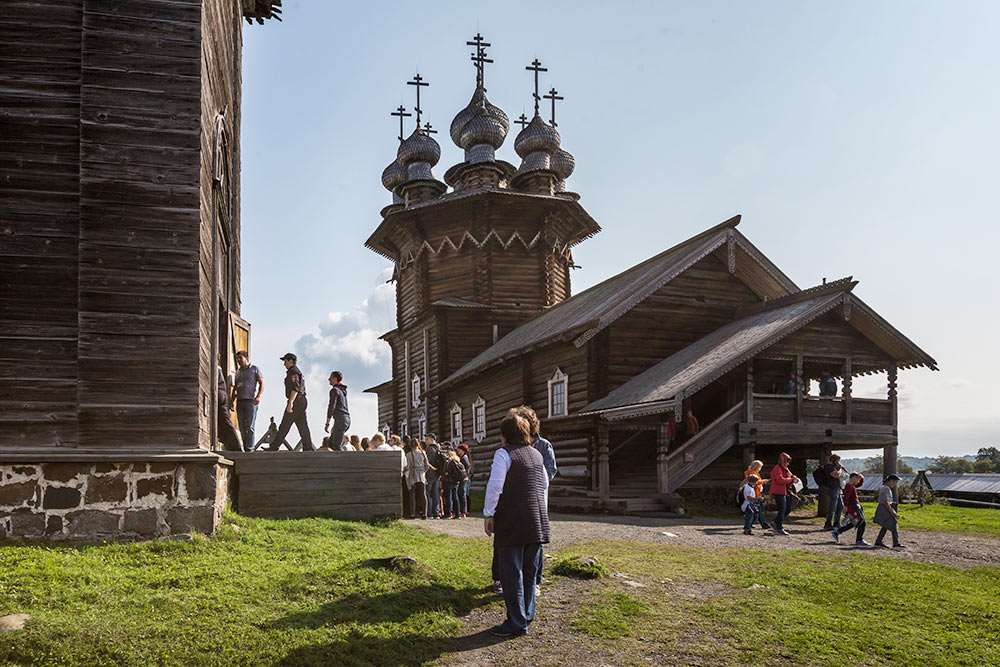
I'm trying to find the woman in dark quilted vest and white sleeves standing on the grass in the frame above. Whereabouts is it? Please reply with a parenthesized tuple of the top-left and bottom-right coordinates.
(483, 415, 549, 637)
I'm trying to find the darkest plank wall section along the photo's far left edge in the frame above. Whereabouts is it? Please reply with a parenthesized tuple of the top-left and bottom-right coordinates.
(0, 0, 83, 448)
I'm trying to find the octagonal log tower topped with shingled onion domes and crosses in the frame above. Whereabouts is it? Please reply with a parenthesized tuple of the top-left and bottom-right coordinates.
(365, 34, 600, 434)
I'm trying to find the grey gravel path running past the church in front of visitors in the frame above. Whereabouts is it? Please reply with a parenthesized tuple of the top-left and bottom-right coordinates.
(405, 513, 1000, 567)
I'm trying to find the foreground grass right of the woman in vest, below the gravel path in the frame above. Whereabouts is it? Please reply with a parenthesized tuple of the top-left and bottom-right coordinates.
(559, 542, 1000, 666)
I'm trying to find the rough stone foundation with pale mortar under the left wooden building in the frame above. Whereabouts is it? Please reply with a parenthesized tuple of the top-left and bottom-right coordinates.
(0, 461, 229, 540)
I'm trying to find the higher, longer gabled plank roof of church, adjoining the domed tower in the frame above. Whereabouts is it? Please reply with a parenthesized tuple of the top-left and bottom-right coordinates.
(437, 215, 798, 389)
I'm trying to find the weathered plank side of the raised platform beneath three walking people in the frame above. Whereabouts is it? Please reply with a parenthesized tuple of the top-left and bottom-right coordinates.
(226, 451, 402, 519)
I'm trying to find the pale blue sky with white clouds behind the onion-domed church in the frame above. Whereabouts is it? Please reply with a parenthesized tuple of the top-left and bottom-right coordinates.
(241, 0, 1000, 456)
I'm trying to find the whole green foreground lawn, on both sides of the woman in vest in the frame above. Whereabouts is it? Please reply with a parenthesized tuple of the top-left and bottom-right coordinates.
(0, 516, 1000, 666)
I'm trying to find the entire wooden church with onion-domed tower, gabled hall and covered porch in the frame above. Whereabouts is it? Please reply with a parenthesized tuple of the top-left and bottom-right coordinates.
(366, 35, 936, 511)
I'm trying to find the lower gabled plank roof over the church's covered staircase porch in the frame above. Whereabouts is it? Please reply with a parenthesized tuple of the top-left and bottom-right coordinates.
(579, 277, 937, 416)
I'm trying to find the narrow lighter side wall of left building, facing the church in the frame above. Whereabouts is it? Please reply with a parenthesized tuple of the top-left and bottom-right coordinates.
(198, 0, 243, 449)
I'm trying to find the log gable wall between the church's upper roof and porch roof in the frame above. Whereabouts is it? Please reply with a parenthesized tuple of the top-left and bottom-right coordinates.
(593, 255, 760, 400)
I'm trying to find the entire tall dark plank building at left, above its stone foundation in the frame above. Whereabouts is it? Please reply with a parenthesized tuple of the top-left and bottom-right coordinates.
(0, 0, 280, 532)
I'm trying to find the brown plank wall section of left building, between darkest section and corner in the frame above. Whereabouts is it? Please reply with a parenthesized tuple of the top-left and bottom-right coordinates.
(77, 0, 201, 450)
